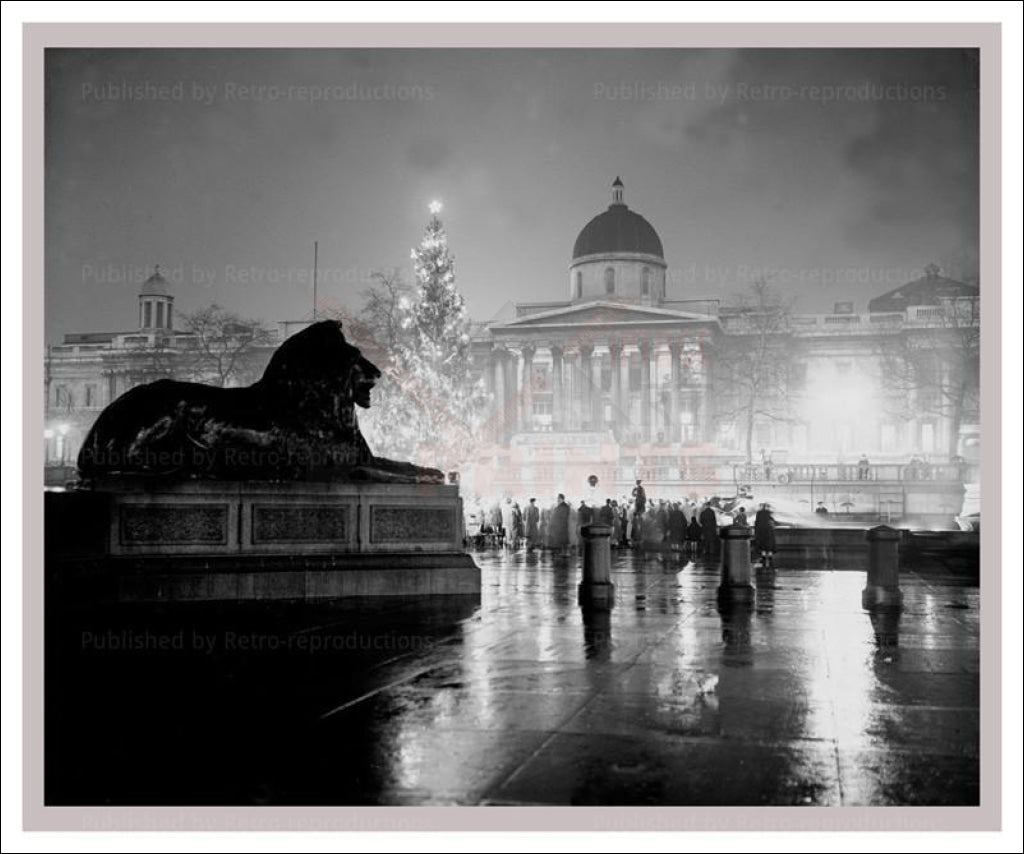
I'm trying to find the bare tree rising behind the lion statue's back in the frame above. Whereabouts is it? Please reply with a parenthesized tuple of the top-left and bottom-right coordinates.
(181, 304, 272, 386)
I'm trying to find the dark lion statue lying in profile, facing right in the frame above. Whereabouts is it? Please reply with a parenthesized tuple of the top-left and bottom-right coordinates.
(78, 321, 443, 483)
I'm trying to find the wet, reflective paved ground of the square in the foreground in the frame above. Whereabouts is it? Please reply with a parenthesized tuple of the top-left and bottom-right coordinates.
(46, 551, 979, 806)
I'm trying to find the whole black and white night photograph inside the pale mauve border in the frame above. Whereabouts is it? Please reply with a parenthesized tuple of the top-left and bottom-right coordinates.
(16, 14, 999, 829)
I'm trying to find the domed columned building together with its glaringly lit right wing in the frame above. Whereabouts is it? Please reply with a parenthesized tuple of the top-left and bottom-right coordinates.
(464, 178, 978, 495)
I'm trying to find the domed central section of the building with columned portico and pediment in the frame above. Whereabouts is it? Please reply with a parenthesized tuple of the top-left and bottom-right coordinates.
(473, 177, 721, 485)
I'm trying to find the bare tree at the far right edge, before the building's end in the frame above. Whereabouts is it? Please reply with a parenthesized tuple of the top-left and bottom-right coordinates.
(880, 297, 981, 459)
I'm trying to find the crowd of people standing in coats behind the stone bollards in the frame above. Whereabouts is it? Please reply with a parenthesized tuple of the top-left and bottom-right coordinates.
(467, 480, 775, 563)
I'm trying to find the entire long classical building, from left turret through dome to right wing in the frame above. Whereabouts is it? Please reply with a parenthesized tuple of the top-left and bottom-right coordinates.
(45, 178, 979, 509)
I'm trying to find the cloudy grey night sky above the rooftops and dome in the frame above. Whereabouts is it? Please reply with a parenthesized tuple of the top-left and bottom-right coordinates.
(45, 49, 978, 343)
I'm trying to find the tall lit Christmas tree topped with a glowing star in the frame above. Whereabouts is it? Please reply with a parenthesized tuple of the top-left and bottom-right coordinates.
(361, 203, 487, 470)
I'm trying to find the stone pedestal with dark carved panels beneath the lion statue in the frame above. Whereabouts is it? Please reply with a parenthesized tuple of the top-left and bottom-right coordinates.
(46, 477, 480, 601)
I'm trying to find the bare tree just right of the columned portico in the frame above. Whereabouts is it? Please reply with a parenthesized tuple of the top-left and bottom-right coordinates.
(713, 279, 793, 464)
